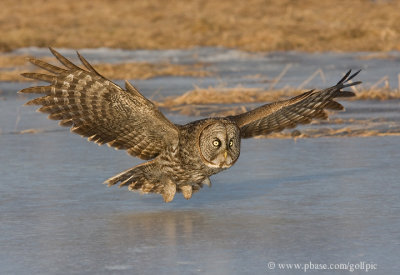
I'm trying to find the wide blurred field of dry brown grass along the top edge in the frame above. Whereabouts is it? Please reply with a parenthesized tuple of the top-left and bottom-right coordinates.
(0, 0, 400, 51)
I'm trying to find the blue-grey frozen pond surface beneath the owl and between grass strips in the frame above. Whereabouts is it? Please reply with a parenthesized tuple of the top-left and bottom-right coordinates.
(0, 48, 400, 274)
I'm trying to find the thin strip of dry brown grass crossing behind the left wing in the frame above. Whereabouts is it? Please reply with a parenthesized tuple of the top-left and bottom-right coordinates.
(0, 55, 211, 81)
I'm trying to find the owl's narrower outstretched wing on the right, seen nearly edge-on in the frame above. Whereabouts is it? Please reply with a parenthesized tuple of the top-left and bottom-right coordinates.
(229, 70, 361, 138)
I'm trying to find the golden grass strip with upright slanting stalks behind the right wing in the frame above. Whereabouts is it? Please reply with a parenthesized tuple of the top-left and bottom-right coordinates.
(158, 66, 400, 112)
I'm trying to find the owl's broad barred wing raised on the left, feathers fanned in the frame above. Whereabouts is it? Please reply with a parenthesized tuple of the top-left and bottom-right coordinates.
(20, 48, 179, 159)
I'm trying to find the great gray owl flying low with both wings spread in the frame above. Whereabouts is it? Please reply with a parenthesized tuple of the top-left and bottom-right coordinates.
(20, 48, 361, 202)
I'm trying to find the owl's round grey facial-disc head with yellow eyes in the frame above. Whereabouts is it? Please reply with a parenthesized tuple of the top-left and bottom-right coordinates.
(199, 120, 240, 168)
